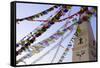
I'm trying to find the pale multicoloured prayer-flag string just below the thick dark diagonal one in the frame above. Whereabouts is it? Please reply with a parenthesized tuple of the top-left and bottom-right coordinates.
(18, 16, 79, 64)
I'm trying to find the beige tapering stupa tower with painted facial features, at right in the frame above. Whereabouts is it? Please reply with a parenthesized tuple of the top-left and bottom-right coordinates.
(72, 16, 97, 62)
